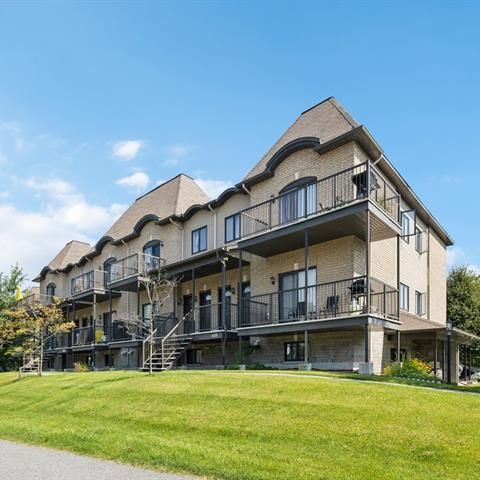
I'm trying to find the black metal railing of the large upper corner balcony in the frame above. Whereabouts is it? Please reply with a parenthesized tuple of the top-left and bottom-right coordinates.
(240, 162, 400, 238)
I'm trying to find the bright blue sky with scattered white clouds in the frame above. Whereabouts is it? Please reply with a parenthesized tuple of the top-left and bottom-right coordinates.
(0, 2, 480, 276)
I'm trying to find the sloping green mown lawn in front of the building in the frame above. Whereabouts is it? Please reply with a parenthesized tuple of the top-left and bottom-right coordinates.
(0, 372, 480, 480)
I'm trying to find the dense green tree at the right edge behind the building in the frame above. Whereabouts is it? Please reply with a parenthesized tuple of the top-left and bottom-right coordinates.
(447, 265, 480, 363)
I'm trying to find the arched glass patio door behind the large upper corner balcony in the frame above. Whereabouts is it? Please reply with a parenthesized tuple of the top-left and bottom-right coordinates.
(279, 177, 317, 224)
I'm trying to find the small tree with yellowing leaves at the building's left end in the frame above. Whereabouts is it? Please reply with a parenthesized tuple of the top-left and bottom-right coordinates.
(0, 298, 74, 375)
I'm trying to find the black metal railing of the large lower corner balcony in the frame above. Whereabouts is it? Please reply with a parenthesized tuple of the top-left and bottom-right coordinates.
(240, 277, 398, 327)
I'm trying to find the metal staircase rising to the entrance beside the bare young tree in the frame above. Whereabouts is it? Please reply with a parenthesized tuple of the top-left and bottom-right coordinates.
(142, 314, 192, 373)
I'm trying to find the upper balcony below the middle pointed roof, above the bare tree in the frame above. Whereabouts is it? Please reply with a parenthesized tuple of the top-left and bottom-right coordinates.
(105, 252, 165, 291)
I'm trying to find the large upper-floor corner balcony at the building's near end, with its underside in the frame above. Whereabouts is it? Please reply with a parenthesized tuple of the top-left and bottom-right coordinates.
(235, 162, 400, 256)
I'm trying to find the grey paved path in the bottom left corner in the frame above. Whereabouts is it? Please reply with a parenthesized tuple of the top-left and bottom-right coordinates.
(0, 440, 200, 480)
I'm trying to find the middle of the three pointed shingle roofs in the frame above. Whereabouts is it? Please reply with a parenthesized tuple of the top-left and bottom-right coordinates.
(103, 173, 209, 241)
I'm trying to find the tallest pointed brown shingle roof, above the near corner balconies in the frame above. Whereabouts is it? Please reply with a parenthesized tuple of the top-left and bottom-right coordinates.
(244, 97, 359, 181)
